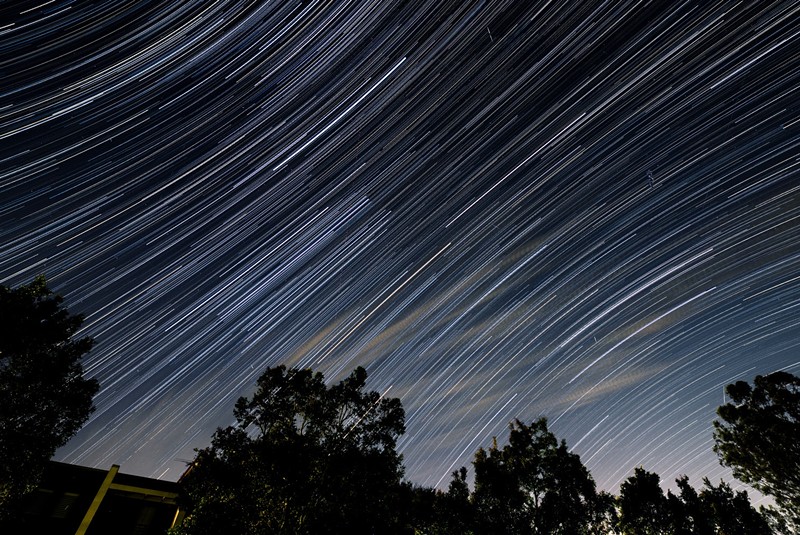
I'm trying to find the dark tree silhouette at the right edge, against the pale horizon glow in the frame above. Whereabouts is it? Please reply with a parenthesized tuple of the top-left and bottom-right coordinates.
(714, 372, 800, 522)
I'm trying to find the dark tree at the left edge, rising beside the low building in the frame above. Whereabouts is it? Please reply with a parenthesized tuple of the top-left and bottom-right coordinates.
(0, 276, 98, 515)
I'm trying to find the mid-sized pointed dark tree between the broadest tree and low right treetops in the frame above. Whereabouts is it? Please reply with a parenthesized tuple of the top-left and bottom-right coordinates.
(473, 418, 597, 534)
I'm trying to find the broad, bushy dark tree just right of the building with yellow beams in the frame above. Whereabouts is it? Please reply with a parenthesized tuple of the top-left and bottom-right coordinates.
(176, 366, 405, 534)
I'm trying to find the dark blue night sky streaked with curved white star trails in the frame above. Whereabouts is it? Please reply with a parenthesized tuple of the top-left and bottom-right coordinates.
(0, 0, 800, 496)
